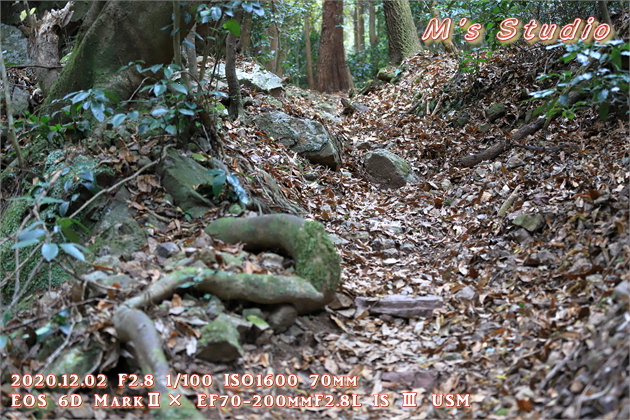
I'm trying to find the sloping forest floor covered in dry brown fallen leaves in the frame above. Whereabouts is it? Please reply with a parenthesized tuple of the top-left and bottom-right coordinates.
(5, 46, 630, 419)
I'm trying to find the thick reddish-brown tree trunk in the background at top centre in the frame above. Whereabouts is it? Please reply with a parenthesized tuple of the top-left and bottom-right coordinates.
(316, 0, 352, 92)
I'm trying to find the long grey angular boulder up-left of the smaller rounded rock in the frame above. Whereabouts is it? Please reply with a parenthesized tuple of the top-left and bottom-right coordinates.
(254, 111, 341, 170)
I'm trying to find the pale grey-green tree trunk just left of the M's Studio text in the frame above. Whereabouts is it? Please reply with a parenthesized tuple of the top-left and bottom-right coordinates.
(383, 0, 422, 65)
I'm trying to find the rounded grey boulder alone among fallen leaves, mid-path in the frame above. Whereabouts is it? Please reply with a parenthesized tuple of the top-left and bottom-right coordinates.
(365, 149, 413, 188)
